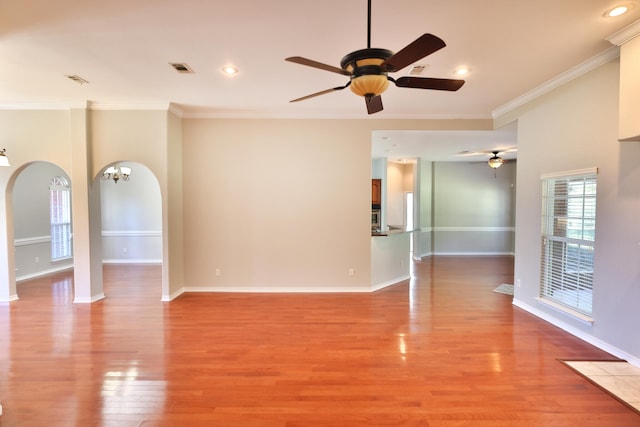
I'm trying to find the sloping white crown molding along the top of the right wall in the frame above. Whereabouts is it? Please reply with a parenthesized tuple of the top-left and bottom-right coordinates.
(491, 46, 620, 120)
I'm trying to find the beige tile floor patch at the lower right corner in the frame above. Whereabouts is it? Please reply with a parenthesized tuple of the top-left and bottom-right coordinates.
(564, 360, 640, 412)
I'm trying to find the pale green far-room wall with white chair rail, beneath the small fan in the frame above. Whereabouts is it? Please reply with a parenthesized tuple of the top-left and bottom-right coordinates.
(416, 161, 516, 256)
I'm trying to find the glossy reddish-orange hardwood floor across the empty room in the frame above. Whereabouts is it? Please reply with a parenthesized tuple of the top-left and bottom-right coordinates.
(0, 257, 640, 427)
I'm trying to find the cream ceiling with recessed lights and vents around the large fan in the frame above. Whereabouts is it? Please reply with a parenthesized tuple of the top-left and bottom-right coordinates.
(0, 0, 640, 159)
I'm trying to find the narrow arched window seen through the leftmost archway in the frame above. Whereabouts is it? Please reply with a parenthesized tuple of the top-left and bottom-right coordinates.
(49, 176, 71, 261)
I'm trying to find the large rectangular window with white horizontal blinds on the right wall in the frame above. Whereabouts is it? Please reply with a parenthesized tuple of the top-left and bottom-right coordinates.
(540, 169, 597, 316)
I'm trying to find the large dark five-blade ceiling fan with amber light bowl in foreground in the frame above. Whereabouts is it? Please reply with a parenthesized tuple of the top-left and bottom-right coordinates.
(285, 0, 464, 114)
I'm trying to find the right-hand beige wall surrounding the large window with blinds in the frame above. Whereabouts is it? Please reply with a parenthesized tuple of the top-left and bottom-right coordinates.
(514, 60, 640, 365)
